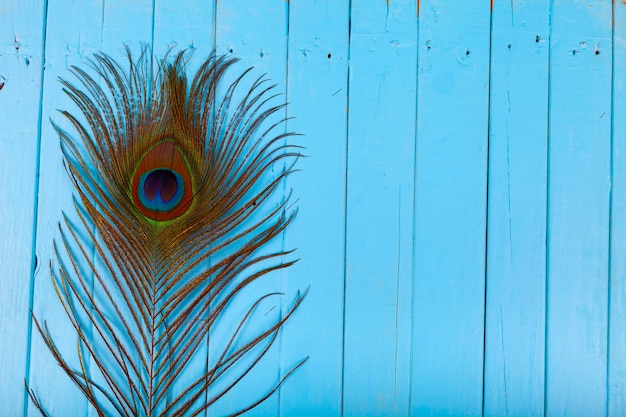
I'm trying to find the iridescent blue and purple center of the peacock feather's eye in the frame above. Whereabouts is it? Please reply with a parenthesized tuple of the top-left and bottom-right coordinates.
(137, 168, 185, 212)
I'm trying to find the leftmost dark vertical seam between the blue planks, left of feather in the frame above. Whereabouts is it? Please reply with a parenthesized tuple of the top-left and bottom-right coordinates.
(24, 0, 48, 417)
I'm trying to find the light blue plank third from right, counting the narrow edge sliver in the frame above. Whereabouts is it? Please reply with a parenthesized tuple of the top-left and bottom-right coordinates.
(484, 0, 550, 416)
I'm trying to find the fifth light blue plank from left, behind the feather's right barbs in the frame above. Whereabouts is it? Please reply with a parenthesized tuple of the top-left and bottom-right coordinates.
(209, 0, 288, 416)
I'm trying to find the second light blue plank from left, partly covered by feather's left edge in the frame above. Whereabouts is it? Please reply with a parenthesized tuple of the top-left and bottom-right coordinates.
(28, 1, 102, 416)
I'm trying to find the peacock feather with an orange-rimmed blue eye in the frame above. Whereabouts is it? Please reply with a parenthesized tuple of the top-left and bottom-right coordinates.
(29, 47, 306, 416)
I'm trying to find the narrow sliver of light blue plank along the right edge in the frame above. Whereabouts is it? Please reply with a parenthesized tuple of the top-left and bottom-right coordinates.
(605, 2, 626, 417)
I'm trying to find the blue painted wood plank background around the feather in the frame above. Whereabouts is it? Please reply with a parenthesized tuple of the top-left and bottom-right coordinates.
(0, 0, 626, 417)
